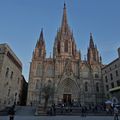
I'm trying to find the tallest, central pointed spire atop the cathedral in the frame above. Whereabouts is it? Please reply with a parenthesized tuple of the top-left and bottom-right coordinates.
(61, 3, 69, 33)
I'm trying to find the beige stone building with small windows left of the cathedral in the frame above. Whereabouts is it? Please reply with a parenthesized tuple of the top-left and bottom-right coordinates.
(0, 44, 22, 106)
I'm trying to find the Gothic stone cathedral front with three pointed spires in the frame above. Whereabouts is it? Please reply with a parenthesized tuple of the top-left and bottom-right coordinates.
(27, 4, 104, 105)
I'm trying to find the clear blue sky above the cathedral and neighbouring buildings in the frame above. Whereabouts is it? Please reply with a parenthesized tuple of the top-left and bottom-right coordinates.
(0, 0, 120, 81)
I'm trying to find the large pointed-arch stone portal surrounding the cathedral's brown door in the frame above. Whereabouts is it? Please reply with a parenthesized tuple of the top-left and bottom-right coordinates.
(57, 78, 79, 105)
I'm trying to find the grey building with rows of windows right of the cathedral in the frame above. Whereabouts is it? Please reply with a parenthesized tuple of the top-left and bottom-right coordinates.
(102, 48, 120, 104)
